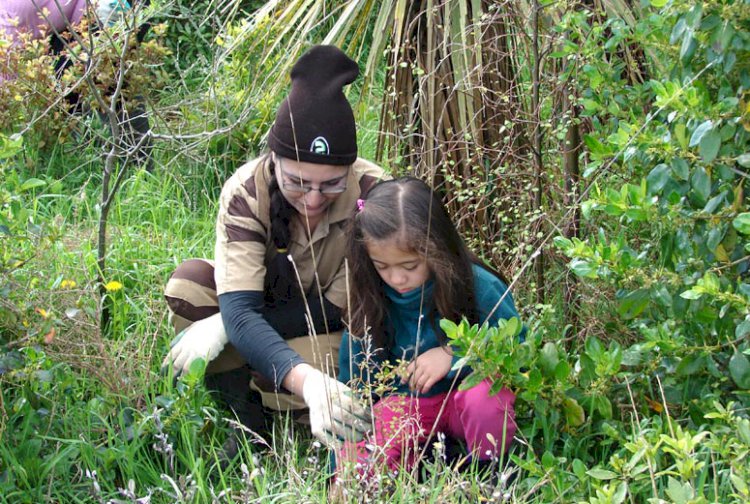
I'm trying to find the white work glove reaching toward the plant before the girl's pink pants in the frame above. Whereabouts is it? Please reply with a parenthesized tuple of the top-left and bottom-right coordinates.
(302, 369, 372, 448)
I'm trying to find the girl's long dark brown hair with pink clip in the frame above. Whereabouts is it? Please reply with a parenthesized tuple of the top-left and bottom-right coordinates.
(347, 177, 500, 348)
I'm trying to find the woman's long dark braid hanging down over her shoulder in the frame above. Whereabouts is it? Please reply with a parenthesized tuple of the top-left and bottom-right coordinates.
(259, 154, 300, 302)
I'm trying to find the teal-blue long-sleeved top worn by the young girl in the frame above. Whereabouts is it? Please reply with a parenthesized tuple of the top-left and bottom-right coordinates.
(339, 264, 526, 397)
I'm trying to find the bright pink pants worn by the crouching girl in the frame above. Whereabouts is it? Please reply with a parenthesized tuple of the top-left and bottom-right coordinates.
(343, 380, 516, 472)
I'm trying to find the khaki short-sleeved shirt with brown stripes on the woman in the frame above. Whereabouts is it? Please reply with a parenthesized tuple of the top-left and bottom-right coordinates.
(214, 157, 384, 308)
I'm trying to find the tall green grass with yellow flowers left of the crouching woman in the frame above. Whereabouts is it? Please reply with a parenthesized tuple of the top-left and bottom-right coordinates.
(0, 133, 528, 502)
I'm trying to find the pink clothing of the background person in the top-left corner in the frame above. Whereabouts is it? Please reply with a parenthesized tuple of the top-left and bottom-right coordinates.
(0, 0, 86, 41)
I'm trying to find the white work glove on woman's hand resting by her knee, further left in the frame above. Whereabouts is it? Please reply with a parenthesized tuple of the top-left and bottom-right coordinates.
(162, 313, 228, 376)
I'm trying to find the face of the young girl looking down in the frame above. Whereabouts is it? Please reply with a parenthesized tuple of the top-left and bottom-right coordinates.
(365, 238, 430, 294)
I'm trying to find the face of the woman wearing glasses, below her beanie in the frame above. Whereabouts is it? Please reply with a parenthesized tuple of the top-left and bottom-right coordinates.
(274, 154, 349, 219)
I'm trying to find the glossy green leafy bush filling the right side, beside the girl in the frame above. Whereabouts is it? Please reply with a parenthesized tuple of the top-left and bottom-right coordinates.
(444, 1, 750, 503)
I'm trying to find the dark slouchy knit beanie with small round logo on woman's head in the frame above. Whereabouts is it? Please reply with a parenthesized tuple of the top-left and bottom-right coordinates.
(268, 45, 359, 165)
